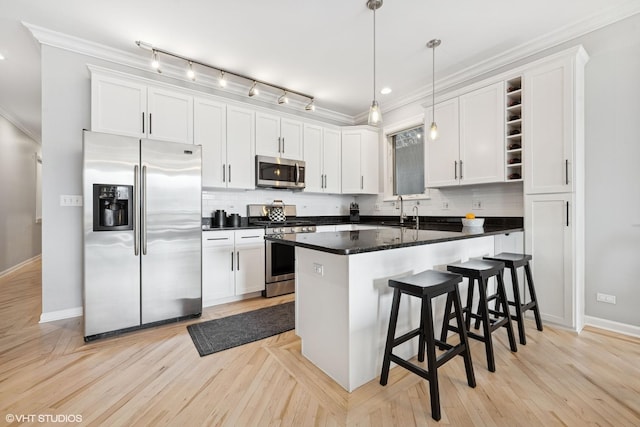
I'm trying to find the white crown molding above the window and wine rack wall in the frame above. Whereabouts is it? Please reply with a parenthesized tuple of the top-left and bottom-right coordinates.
(380, 0, 640, 120)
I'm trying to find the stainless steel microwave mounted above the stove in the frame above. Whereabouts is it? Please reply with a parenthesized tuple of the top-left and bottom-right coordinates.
(256, 156, 306, 190)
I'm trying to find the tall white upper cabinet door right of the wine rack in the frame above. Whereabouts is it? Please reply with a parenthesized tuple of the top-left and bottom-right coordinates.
(523, 59, 575, 194)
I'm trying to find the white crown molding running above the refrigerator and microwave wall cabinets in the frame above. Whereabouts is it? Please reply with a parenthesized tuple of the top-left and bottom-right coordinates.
(22, 22, 354, 125)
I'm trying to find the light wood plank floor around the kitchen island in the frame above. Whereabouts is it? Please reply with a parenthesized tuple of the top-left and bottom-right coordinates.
(0, 262, 640, 426)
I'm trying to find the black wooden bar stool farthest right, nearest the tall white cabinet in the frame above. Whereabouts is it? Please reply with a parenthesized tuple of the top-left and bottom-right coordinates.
(484, 252, 542, 345)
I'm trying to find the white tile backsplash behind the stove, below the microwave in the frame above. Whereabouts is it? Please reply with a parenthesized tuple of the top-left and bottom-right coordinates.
(202, 190, 355, 217)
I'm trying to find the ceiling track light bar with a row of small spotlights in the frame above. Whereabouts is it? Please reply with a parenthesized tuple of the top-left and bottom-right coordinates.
(136, 40, 316, 111)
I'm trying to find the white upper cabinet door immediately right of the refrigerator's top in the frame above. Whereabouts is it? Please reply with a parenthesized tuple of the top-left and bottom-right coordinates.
(193, 97, 227, 187)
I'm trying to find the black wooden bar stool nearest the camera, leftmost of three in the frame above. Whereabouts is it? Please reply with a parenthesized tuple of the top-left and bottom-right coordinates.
(380, 270, 476, 421)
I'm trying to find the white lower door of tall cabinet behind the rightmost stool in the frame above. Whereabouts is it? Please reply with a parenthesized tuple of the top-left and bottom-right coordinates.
(524, 193, 579, 329)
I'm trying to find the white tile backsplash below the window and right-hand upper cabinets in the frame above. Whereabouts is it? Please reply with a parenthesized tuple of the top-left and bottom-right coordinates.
(356, 183, 524, 217)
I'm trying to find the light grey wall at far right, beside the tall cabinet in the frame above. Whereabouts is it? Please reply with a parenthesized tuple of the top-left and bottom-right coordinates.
(585, 15, 640, 333)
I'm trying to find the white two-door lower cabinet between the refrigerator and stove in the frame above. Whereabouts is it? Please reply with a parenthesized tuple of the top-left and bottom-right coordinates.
(202, 229, 264, 307)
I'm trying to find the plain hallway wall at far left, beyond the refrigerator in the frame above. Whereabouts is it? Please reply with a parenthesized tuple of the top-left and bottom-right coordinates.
(0, 116, 42, 275)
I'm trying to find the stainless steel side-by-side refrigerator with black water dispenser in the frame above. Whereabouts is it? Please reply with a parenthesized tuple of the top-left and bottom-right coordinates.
(83, 131, 202, 341)
